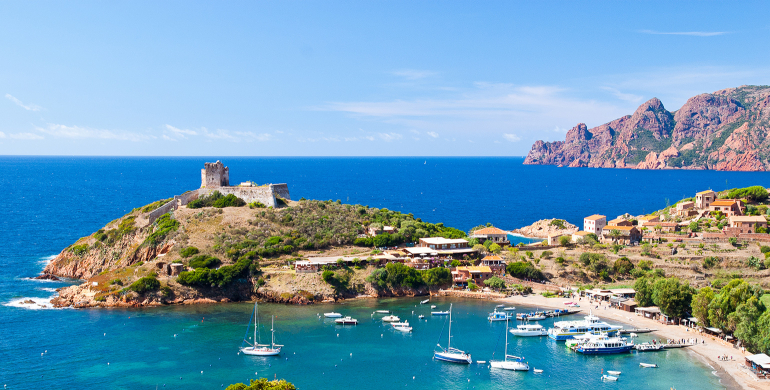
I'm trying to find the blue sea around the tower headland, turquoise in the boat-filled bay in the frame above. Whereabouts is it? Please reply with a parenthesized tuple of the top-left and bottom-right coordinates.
(0, 156, 768, 390)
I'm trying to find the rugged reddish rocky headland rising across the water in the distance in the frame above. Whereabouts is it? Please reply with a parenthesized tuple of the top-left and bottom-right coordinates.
(524, 86, 770, 171)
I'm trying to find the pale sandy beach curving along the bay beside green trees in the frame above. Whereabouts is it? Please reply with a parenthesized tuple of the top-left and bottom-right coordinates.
(500, 294, 770, 390)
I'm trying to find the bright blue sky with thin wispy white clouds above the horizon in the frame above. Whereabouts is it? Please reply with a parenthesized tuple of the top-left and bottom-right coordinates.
(0, 1, 770, 156)
